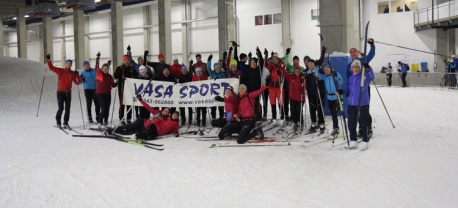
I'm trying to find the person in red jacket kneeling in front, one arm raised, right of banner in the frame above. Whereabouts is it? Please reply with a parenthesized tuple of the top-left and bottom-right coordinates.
(218, 81, 270, 144)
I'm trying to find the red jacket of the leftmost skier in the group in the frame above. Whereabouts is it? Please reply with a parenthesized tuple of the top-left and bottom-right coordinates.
(48, 60, 80, 92)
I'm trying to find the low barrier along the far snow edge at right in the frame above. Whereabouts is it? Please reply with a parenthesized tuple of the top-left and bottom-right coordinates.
(374, 72, 458, 89)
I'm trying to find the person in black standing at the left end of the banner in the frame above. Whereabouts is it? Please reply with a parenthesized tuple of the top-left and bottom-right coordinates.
(114, 55, 138, 125)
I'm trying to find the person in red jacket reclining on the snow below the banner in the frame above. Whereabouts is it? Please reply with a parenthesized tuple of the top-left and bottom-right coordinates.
(107, 95, 180, 140)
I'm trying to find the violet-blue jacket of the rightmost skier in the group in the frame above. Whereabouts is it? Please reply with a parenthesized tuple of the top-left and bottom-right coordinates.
(344, 68, 374, 106)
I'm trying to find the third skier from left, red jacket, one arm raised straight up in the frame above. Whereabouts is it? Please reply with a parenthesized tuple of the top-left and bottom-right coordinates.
(95, 52, 117, 126)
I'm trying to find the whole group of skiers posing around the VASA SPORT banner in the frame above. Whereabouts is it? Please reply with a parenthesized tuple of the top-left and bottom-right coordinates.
(47, 38, 375, 148)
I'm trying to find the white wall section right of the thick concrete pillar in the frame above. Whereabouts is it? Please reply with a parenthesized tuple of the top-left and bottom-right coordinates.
(360, 1, 437, 72)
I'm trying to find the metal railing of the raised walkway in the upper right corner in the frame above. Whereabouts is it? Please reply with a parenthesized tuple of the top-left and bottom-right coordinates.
(413, 1, 458, 26)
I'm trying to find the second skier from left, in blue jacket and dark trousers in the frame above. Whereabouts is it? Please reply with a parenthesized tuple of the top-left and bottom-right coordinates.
(80, 61, 100, 123)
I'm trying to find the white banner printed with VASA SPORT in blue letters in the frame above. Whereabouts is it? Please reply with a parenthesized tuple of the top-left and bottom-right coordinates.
(123, 78, 239, 107)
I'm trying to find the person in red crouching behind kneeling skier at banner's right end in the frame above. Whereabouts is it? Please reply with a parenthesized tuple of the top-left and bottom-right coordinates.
(212, 86, 239, 128)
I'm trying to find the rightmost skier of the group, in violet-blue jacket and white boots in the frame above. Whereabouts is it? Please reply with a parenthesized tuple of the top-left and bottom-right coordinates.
(336, 60, 374, 151)
